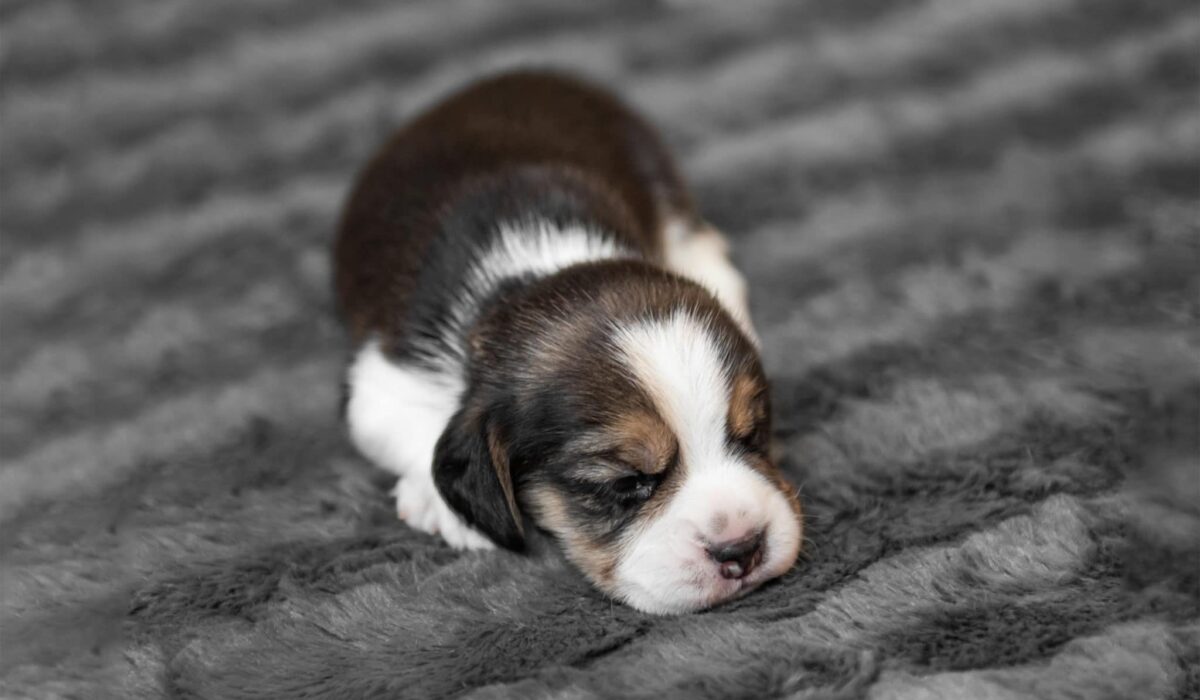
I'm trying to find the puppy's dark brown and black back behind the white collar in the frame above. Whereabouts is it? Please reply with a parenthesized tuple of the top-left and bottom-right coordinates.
(335, 72, 691, 340)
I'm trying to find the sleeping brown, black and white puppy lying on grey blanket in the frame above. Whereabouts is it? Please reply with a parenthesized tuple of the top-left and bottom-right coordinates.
(335, 72, 802, 614)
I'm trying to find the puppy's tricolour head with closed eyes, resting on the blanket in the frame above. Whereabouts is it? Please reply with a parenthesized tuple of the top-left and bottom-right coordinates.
(434, 262, 802, 614)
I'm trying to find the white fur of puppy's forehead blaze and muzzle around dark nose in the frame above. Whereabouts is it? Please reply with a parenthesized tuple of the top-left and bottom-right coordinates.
(614, 311, 800, 614)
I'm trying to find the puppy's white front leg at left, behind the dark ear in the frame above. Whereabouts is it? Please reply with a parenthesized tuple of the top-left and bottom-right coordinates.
(346, 341, 494, 549)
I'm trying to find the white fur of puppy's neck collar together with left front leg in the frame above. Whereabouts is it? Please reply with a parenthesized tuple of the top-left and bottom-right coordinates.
(347, 222, 629, 549)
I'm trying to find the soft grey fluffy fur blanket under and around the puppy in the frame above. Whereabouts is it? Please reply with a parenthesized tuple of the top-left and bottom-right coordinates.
(0, 0, 1200, 699)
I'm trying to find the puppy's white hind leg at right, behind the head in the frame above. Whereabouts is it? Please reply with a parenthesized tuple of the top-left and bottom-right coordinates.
(662, 216, 758, 345)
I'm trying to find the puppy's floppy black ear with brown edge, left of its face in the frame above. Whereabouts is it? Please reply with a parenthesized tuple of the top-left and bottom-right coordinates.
(433, 403, 524, 551)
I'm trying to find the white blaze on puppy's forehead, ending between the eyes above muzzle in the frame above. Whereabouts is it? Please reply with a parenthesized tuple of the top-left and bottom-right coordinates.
(613, 310, 730, 469)
